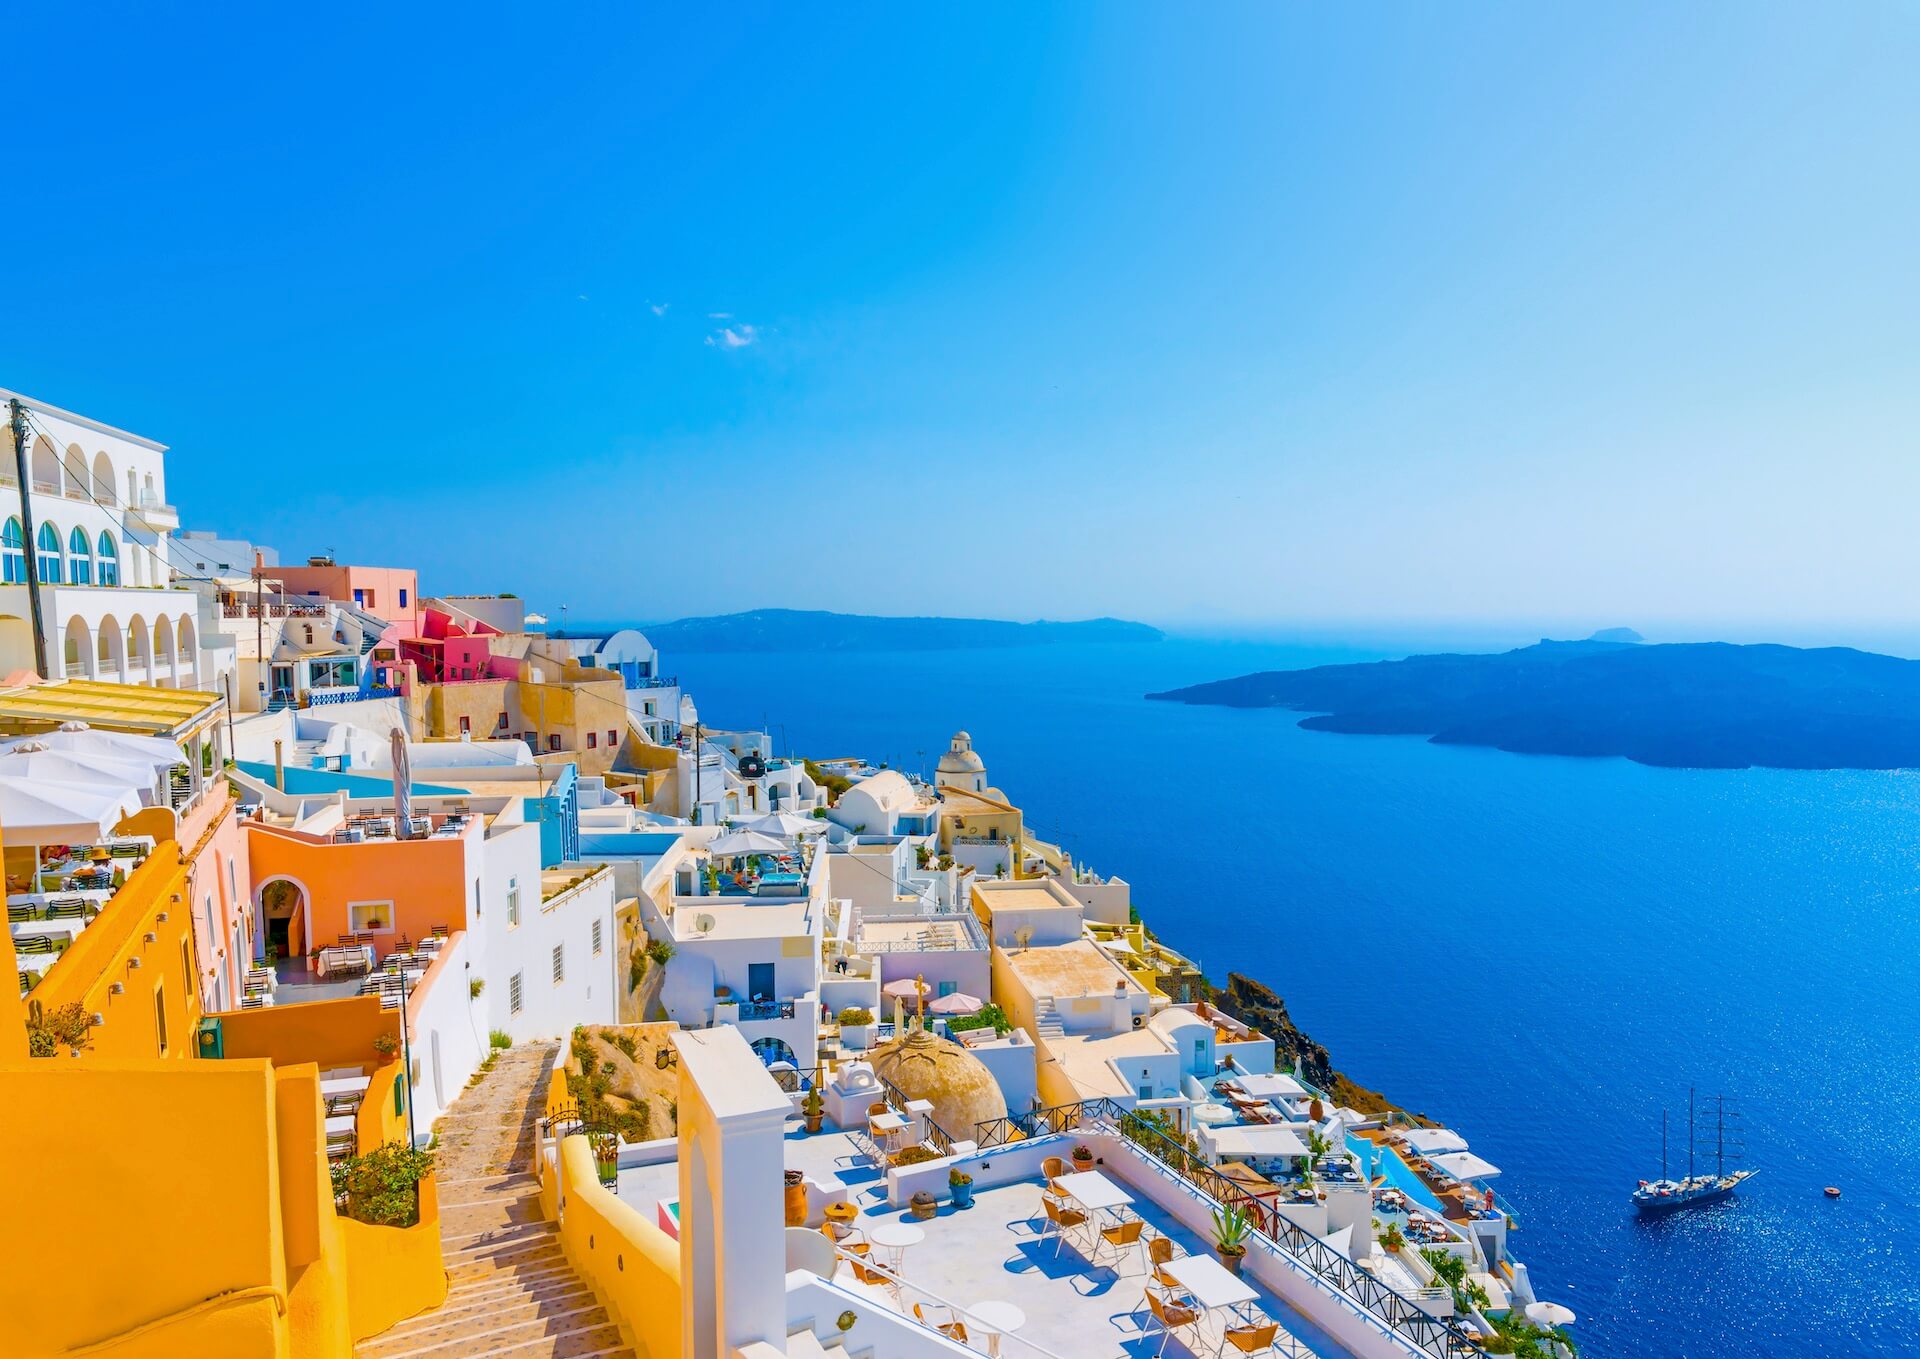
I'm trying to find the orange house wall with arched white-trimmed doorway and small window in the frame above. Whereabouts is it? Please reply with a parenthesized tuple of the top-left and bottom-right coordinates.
(246, 818, 486, 958)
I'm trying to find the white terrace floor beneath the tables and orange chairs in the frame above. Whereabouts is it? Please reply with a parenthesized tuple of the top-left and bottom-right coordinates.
(768, 1133, 1348, 1359)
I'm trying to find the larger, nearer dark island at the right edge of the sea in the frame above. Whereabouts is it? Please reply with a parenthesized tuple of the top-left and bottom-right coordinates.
(1146, 630, 1920, 770)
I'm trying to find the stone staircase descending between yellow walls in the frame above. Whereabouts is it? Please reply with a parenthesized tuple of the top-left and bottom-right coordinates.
(353, 1042, 645, 1359)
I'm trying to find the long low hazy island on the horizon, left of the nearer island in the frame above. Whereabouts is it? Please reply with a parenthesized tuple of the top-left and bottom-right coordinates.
(645, 608, 1162, 651)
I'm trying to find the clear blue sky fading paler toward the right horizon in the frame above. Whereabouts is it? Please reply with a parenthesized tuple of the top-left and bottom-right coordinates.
(0, 4, 1920, 635)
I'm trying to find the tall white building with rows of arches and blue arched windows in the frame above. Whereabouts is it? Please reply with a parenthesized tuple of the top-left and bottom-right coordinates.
(0, 390, 210, 691)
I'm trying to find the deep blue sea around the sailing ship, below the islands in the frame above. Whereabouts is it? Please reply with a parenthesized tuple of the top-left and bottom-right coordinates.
(668, 639, 1920, 1359)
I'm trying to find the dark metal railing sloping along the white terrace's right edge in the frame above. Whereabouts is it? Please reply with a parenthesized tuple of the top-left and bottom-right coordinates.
(1104, 1102, 1478, 1359)
